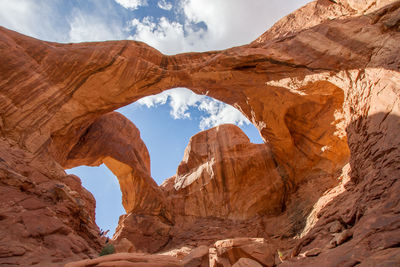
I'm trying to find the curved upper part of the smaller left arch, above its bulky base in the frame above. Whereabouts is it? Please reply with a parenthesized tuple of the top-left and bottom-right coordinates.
(56, 112, 165, 218)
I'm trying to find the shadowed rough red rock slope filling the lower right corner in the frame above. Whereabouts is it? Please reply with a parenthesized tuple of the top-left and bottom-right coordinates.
(282, 112, 400, 266)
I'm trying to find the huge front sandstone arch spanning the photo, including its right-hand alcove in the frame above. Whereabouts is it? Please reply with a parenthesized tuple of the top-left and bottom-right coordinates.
(1, 2, 398, 185)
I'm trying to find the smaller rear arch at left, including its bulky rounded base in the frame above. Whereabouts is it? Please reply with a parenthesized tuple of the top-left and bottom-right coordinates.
(53, 112, 172, 253)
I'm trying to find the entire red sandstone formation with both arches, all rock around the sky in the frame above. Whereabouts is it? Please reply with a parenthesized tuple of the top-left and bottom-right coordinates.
(0, 0, 400, 266)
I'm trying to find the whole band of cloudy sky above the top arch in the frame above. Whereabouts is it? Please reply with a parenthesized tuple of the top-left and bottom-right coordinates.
(0, 0, 310, 50)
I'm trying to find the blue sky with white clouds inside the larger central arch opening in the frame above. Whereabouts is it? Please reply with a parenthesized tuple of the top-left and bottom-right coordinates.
(117, 88, 263, 184)
